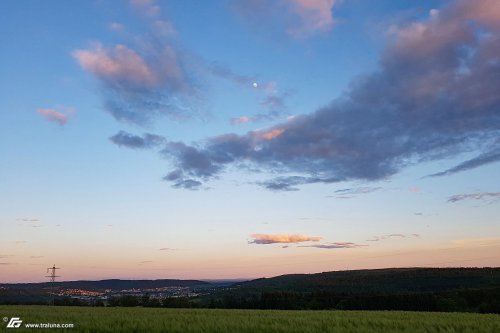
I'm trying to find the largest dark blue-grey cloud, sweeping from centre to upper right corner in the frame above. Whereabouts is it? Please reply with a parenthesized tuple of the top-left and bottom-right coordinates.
(159, 0, 500, 191)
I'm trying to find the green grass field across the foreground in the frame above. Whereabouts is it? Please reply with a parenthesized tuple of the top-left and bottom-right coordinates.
(0, 306, 500, 333)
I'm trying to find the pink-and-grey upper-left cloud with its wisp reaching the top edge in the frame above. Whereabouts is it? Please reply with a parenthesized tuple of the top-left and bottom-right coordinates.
(72, 0, 203, 125)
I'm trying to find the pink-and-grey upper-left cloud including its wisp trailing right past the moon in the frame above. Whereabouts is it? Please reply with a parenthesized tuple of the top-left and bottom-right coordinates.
(72, 0, 289, 125)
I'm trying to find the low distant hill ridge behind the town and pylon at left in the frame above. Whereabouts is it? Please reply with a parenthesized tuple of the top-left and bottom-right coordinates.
(0, 279, 211, 291)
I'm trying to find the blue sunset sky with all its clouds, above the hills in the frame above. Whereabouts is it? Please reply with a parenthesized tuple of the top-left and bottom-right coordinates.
(0, 0, 500, 282)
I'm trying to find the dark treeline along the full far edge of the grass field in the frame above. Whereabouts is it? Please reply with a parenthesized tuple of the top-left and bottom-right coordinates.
(0, 288, 500, 314)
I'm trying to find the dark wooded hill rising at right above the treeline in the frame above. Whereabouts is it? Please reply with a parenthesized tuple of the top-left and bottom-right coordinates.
(233, 268, 500, 294)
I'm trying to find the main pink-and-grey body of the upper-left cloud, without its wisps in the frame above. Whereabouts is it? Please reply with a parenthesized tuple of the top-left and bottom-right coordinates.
(73, 39, 200, 125)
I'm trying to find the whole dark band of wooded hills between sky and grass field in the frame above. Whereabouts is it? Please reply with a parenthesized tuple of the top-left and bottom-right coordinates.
(0, 268, 500, 313)
